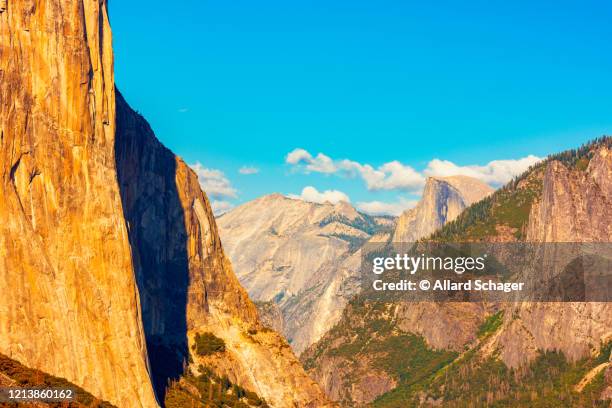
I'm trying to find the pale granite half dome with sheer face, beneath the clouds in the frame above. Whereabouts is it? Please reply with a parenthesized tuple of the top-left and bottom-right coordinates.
(393, 176, 493, 242)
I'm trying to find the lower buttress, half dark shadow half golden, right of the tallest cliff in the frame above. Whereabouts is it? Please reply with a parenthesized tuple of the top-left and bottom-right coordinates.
(116, 94, 325, 407)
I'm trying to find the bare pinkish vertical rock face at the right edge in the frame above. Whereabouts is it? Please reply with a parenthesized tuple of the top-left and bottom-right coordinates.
(495, 146, 612, 367)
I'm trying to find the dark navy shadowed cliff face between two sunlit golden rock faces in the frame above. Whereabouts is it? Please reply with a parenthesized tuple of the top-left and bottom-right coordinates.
(115, 92, 189, 401)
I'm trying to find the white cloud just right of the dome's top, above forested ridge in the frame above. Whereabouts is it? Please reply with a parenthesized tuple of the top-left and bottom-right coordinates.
(423, 155, 542, 187)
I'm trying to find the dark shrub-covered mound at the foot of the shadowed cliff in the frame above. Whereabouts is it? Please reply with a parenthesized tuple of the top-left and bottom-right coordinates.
(165, 366, 268, 408)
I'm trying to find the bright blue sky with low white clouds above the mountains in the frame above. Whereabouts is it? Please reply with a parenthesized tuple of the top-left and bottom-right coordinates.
(110, 0, 612, 212)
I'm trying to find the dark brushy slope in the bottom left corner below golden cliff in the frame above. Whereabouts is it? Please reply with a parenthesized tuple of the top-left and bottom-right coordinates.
(0, 354, 114, 408)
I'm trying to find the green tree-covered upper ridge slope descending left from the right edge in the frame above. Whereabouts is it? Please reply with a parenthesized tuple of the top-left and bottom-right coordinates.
(430, 136, 612, 242)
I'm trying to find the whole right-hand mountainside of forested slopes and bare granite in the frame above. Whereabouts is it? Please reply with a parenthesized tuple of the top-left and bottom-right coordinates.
(301, 137, 612, 407)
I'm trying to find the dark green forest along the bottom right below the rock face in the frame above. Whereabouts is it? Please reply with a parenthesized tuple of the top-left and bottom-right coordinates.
(373, 344, 610, 408)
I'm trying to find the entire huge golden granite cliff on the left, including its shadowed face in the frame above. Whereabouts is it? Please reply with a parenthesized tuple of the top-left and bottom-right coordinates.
(0, 0, 326, 407)
